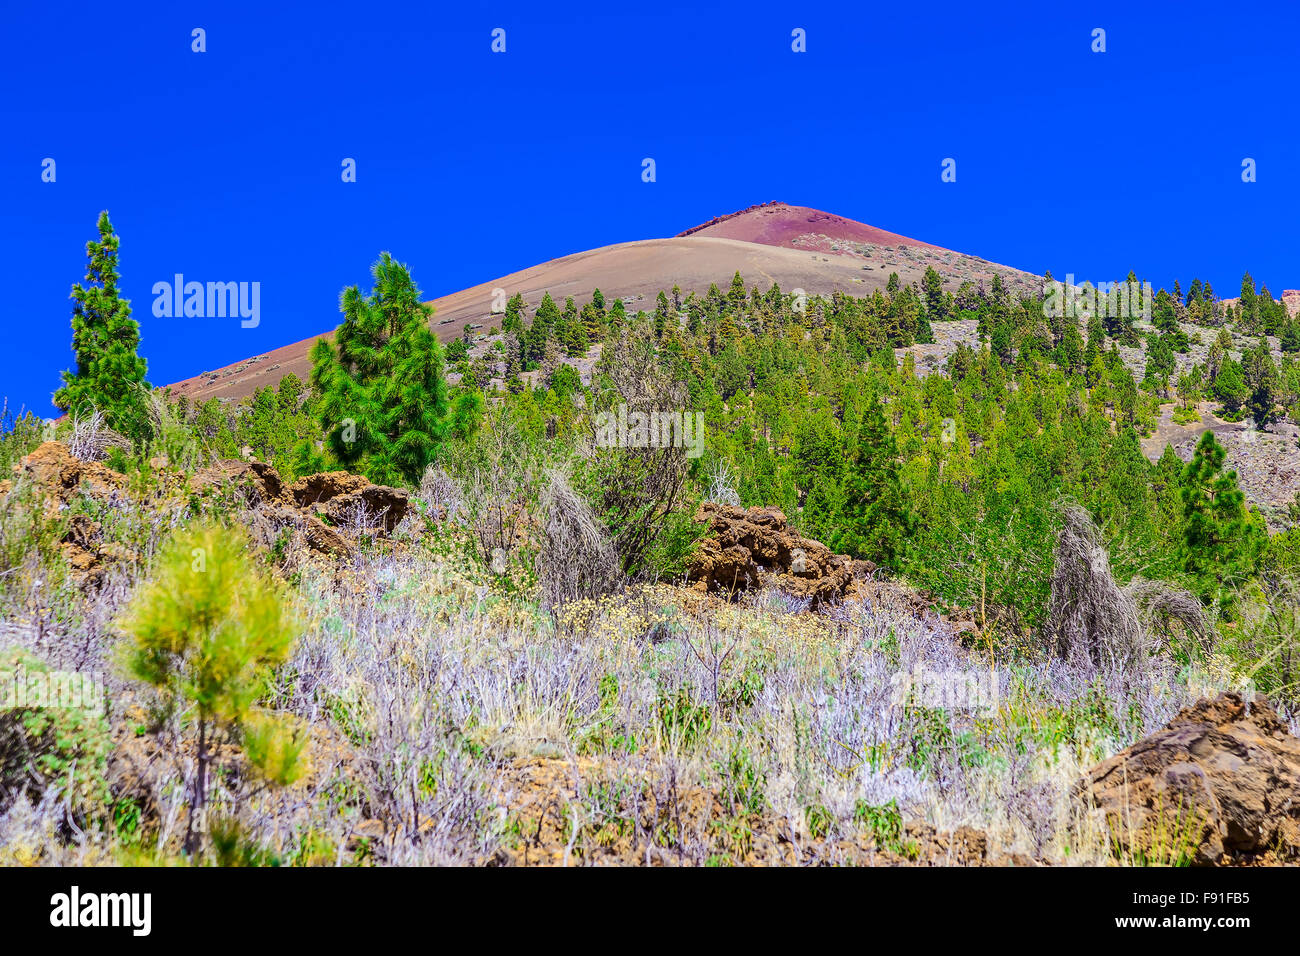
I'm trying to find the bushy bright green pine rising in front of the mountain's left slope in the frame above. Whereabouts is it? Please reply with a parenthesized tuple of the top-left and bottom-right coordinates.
(312, 252, 447, 484)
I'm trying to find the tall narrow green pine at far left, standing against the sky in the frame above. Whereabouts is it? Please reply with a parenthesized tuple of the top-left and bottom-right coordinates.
(55, 211, 150, 438)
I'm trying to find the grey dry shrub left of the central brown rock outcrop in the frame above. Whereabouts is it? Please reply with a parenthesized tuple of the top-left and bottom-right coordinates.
(537, 470, 621, 610)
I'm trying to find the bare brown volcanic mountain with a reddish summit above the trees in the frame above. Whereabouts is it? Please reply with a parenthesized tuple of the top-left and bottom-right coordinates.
(170, 202, 1039, 401)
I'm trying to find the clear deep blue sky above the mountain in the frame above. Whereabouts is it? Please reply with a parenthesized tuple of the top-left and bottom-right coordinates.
(0, 0, 1300, 415)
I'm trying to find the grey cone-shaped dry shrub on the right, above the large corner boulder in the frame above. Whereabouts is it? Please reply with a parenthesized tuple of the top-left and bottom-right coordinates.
(1047, 505, 1151, 672)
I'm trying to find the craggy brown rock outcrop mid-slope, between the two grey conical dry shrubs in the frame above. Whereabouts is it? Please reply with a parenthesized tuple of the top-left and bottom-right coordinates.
(686, 502, 876, 610)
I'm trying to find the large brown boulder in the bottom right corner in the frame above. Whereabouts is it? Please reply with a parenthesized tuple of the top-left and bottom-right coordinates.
(1074, 693, 1300, 865)
